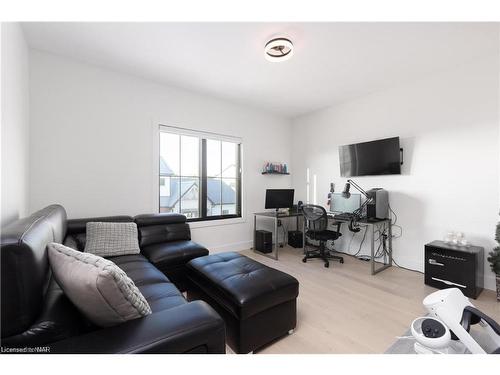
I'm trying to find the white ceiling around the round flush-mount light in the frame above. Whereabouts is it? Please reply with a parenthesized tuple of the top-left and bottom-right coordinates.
(23, 22, 499, 117)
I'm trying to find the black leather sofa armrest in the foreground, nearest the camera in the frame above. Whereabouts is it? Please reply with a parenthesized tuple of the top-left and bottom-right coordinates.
(50, 301, 226, 353)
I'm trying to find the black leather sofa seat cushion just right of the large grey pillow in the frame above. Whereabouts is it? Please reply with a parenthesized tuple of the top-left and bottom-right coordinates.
(108, 255, 187, 313)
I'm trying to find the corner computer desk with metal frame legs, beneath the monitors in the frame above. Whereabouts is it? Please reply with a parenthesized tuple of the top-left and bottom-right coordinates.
(253, 211, 392, 275)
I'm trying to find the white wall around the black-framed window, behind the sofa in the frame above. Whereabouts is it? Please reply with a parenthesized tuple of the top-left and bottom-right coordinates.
(30, 51, 291, 250)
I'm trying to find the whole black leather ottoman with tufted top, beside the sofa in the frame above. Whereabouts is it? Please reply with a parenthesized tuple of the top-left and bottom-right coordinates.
(187, 252, 299, 353)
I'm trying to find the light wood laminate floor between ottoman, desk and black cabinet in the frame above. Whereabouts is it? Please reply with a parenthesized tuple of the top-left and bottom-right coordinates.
(235, 247, 500, 354)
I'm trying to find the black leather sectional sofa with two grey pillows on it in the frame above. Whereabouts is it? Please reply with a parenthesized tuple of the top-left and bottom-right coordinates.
(1, 205, 225, 353)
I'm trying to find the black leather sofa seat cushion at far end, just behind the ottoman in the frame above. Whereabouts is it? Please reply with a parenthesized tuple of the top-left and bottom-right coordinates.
(141, 241, 208, 271)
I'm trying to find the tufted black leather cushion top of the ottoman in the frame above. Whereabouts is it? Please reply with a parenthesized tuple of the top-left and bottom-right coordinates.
(187, 252, 299, 320)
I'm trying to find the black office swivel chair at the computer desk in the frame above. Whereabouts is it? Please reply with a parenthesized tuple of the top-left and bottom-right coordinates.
(302, 204, 344, 268)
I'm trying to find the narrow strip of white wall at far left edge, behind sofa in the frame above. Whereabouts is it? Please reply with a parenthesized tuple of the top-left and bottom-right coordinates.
(1, 22, 29, 226)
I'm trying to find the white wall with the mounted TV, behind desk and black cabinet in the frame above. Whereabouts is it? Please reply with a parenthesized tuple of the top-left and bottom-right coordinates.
(292, 56, 499, 289)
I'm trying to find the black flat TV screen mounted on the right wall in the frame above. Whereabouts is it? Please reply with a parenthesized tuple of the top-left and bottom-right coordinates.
(339, 137, 401, 177)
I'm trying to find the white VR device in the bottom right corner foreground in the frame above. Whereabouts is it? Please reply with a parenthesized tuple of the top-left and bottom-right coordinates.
(411, 288, 500, 354)
